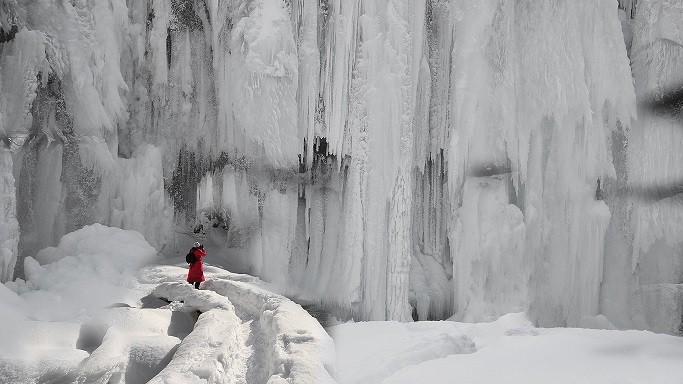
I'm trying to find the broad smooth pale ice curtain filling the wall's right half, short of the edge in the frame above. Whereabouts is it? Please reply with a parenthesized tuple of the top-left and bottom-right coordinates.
(448, 1, 635, 325)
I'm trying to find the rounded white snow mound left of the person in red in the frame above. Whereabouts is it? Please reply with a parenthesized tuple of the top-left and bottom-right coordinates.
(7, 224, 157, 321)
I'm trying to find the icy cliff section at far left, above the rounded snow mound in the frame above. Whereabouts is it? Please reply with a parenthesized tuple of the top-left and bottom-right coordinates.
(0, 1, 170, 279)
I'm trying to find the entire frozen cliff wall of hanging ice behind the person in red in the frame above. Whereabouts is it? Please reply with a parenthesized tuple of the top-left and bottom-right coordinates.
(0, 0, 683, 333)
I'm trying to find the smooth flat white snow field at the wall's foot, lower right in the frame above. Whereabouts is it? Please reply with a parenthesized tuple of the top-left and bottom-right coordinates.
(330, 314, 683, 384)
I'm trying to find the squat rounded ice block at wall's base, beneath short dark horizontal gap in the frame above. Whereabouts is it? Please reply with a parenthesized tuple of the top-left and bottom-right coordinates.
(453, 177, 531, 321)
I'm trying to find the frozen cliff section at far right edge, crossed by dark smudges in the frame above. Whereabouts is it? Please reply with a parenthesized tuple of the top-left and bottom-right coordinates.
(603, 0, 683, 332)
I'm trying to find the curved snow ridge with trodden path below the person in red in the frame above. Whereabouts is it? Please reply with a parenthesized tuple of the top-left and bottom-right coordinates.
(148, 267, 335, 383)
